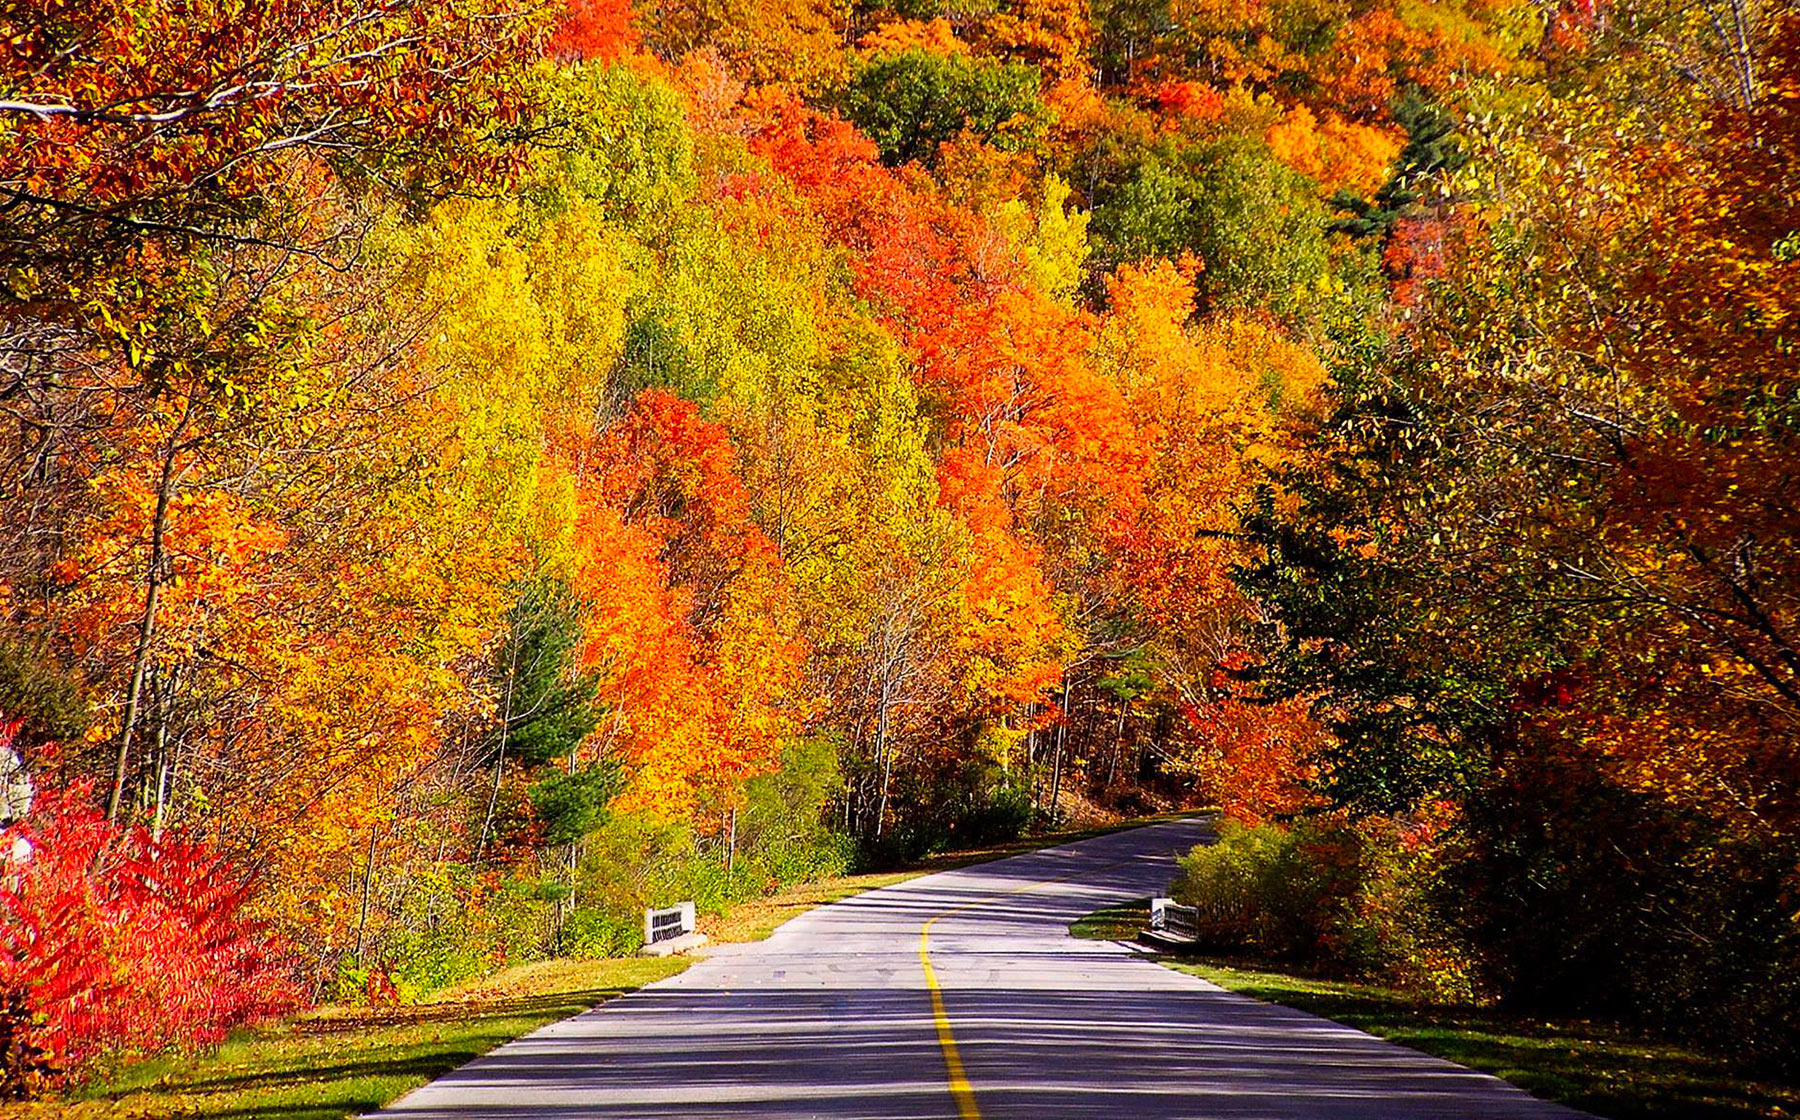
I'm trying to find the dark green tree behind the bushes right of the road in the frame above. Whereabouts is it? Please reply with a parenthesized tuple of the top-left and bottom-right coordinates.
(1233, 363, 1546, 814)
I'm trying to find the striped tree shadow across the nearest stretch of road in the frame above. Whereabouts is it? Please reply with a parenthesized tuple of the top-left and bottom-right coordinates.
(390, 989, 1573, 1120)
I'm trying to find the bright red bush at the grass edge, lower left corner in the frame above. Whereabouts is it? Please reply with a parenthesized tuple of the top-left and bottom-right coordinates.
(0, 759, 301, 1071)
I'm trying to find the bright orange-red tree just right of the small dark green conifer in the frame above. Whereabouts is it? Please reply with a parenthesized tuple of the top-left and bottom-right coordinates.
(574, 389, 805, 816)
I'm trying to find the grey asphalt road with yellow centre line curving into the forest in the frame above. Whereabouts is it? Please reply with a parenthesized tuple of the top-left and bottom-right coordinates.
(382, 821, 1582, 1120)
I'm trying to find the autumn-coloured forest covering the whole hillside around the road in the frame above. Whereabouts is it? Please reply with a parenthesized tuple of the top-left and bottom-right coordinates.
(0, 0, 1800, 1095)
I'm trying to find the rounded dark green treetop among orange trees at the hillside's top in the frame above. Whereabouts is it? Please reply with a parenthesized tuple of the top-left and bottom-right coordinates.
(841, 49, 1044, 164)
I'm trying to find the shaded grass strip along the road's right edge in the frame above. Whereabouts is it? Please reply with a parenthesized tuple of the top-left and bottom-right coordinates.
(1069, 899, 1800, 1120)
